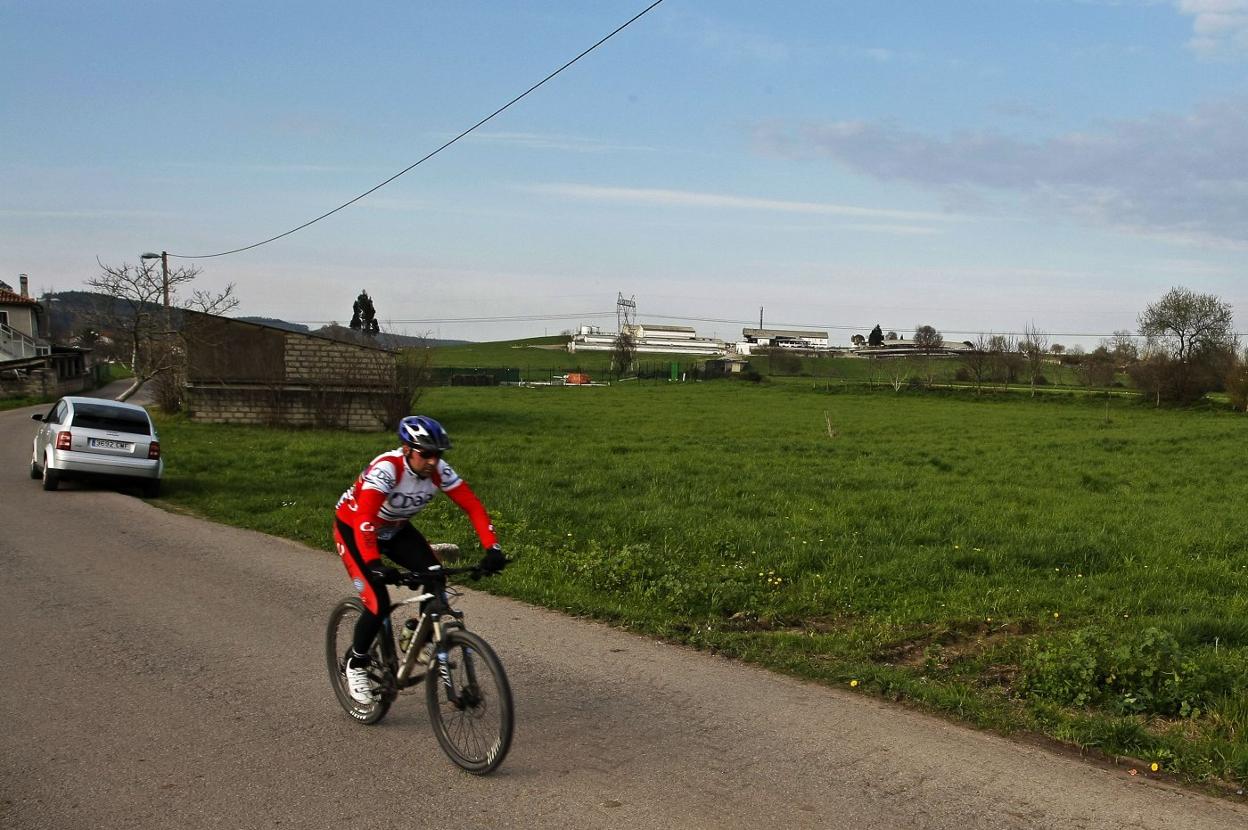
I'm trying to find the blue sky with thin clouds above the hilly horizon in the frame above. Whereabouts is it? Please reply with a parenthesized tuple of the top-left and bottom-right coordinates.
(0, 0, 1248, 347)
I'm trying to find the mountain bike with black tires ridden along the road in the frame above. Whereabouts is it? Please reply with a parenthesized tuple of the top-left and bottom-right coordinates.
(326, 545, 513, 775)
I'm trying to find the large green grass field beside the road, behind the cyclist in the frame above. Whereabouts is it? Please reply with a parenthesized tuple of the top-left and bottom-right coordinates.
(148, 382, 1248, 781)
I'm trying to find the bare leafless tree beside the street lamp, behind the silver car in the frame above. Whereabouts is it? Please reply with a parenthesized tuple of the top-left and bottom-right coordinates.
(86, 260, 238, 401)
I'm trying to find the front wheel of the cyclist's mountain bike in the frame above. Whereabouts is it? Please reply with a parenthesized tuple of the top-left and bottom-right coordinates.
(424, 629, 514, 775)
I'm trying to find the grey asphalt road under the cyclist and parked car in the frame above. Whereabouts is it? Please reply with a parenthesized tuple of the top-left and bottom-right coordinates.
(0, 394, 1248, 830)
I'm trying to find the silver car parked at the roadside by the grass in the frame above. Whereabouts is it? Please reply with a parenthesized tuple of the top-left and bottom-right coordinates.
(30, 397, 165, 498)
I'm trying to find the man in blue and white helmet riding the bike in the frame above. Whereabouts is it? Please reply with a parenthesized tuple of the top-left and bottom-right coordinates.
(333, 416, 508, 704)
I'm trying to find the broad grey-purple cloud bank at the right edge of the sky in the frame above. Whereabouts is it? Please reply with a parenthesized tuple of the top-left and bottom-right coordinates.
(756, 99, 1248, 246)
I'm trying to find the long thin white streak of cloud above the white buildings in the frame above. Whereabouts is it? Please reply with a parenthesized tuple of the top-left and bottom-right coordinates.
(524, 183, 962, 227)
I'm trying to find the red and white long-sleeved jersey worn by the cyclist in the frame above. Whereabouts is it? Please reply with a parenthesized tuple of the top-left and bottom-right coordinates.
(334, 449, 498, 562)
